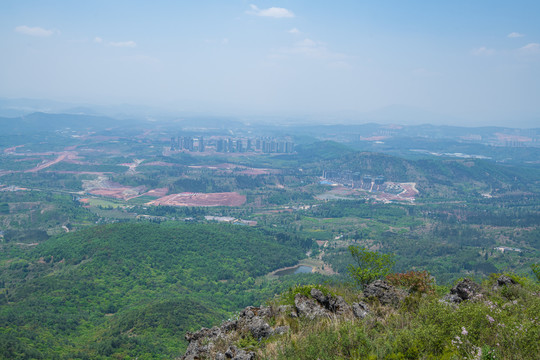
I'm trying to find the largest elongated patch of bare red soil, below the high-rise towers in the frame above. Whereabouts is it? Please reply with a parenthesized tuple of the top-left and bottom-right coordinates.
(148, 192, 246, 206)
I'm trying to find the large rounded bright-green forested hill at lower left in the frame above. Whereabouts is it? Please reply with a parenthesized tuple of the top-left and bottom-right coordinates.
(0, 223, 311, 359)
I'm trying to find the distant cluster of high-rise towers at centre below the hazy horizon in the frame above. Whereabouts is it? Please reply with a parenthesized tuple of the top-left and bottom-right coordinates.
(171, 136, 294, 154)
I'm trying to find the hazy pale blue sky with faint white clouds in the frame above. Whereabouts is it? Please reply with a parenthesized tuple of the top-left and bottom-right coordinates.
(0, 0, 540, 127)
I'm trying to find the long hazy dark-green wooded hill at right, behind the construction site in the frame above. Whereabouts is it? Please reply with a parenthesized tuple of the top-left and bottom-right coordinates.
(297, 141, 540, 197)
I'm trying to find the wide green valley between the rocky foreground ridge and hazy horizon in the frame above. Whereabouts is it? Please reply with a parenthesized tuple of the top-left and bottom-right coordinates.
(0, 115, 540, 359)
